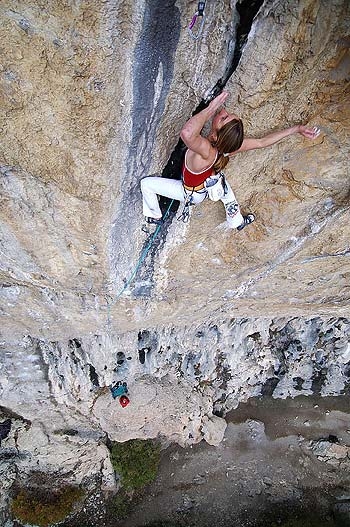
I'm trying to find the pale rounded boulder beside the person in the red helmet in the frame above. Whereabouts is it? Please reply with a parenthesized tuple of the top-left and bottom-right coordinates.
(92, 375, 220, 445)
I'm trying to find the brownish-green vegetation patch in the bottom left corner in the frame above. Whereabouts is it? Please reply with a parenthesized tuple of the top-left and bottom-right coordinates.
(11, 485, 84, 527)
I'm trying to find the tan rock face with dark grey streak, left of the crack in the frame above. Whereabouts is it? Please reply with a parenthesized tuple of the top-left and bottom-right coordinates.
(0, 0, 235, 335)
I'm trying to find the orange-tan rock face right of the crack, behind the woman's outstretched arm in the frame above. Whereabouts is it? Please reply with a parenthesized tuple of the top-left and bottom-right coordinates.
(166, 1, 349, 326)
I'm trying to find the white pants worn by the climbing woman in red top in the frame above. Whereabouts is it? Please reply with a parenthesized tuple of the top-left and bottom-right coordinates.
(141, 176, 244, 229)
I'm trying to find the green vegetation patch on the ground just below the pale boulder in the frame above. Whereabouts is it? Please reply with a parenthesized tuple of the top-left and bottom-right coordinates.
(110, 439, 160, 489)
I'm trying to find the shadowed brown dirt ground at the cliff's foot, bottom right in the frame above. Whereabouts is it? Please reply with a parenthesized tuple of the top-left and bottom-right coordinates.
(117, 396, 350, 527)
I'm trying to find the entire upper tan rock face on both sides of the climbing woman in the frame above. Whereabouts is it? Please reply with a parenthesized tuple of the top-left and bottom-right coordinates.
(0, 0, 349, 338)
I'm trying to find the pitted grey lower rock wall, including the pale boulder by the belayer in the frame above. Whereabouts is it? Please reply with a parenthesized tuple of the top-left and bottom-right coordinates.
(1, 318, 350, 444)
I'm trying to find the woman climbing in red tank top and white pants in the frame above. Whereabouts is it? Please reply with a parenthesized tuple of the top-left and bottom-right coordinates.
(141, 91, 320, 230)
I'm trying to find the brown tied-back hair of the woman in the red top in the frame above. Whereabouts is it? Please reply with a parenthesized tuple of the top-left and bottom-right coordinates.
(213, 119, 244, 173)
